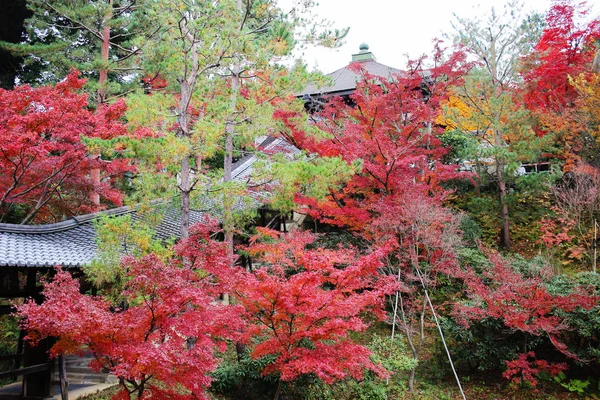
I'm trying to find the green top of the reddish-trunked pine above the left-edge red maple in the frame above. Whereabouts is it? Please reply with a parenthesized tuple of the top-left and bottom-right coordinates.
(0, 0, 156, 103)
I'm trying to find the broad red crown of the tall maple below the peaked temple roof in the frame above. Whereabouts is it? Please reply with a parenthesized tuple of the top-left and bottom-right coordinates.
(276, 44, 468, 239)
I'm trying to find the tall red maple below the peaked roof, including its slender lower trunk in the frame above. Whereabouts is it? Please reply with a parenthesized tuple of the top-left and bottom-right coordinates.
(277, 42, 469, 391)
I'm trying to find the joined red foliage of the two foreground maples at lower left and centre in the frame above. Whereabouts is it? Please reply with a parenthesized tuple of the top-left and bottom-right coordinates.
(19, 221, 395, 398)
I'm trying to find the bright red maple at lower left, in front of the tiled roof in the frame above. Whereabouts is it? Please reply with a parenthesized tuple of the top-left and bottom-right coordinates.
(18, 221, 243, 399)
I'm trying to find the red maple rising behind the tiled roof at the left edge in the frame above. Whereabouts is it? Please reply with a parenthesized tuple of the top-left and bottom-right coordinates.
(0, 72, 137, 224)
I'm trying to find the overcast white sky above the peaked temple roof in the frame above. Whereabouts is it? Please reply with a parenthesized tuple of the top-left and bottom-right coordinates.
(279, 0, 564, 73)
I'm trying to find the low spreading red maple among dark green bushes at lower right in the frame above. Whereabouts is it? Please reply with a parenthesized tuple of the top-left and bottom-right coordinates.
(453, 251, 598, 385)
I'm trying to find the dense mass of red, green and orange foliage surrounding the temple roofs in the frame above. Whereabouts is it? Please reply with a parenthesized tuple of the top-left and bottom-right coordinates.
(0, 0, 600, 399)
